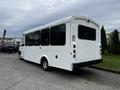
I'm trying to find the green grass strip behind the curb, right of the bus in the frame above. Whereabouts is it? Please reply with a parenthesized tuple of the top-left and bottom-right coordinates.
(96, 54, 120, 72)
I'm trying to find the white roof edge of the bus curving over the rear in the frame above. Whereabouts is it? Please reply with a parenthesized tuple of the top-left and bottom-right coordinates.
(23, 15, 99, 34)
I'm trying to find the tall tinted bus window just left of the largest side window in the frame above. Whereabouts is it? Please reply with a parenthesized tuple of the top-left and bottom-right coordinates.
(41, 28, 49, 46)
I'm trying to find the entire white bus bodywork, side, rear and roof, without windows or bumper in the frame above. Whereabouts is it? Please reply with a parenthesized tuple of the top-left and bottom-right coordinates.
(20, 17, 101, 71)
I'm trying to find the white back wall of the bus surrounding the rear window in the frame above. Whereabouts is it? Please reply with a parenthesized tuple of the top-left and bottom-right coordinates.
(72, 19, 101, 63)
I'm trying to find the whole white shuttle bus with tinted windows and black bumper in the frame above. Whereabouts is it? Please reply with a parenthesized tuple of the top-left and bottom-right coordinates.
(19, 16, 102, 71)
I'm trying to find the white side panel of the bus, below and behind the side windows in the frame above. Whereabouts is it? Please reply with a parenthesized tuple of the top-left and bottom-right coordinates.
(21, 22, 72, 70)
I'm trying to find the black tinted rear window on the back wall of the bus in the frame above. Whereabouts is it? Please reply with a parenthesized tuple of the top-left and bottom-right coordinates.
(78, 25, 96, 41)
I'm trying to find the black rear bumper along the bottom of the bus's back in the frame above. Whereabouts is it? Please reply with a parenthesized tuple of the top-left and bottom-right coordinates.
(73, 59, 102, 70)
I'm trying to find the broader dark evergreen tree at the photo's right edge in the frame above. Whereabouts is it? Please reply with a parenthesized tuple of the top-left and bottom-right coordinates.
(111, 30, 120, 54)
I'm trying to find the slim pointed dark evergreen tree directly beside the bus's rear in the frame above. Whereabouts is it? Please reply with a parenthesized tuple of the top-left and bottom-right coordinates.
(101, 26, 107, 53)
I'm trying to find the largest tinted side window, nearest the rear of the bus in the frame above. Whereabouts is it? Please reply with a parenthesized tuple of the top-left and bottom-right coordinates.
(50, 24, 66, 45)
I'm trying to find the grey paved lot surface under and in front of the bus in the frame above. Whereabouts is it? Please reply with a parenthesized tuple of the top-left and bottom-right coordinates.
(0, 53, 120, 90)
